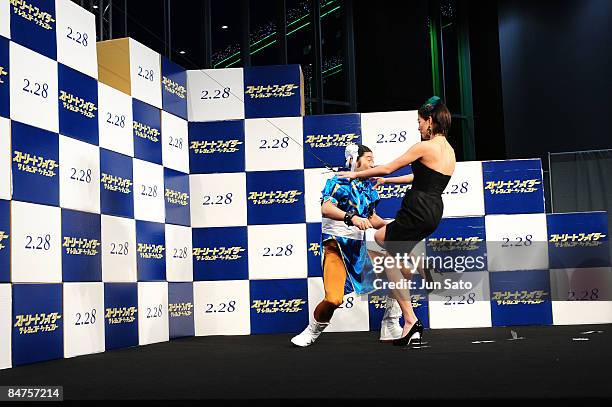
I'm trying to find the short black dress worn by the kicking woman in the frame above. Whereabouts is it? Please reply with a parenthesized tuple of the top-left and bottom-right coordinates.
(385, 160, 451, 255)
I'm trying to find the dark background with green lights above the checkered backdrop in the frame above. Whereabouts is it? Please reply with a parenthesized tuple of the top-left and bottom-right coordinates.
(81, 0, 612, 215)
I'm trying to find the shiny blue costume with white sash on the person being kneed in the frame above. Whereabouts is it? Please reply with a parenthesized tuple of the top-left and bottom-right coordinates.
(319, 176, 380, 294)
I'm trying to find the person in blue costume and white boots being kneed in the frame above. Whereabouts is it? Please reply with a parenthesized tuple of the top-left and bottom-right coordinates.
(291, 144, 392, 347)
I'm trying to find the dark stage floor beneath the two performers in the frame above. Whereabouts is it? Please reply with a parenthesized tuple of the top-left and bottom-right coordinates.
(0, 325, 612, 400)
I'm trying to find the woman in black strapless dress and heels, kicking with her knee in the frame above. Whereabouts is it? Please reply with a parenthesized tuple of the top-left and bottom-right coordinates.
(338, 96, 455, 346)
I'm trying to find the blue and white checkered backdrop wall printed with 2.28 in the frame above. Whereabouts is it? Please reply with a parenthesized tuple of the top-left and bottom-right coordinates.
(0, 0, 612, 368)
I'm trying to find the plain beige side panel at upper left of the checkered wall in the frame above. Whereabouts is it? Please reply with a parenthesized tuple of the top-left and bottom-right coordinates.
(96, 38, 132, 95)
